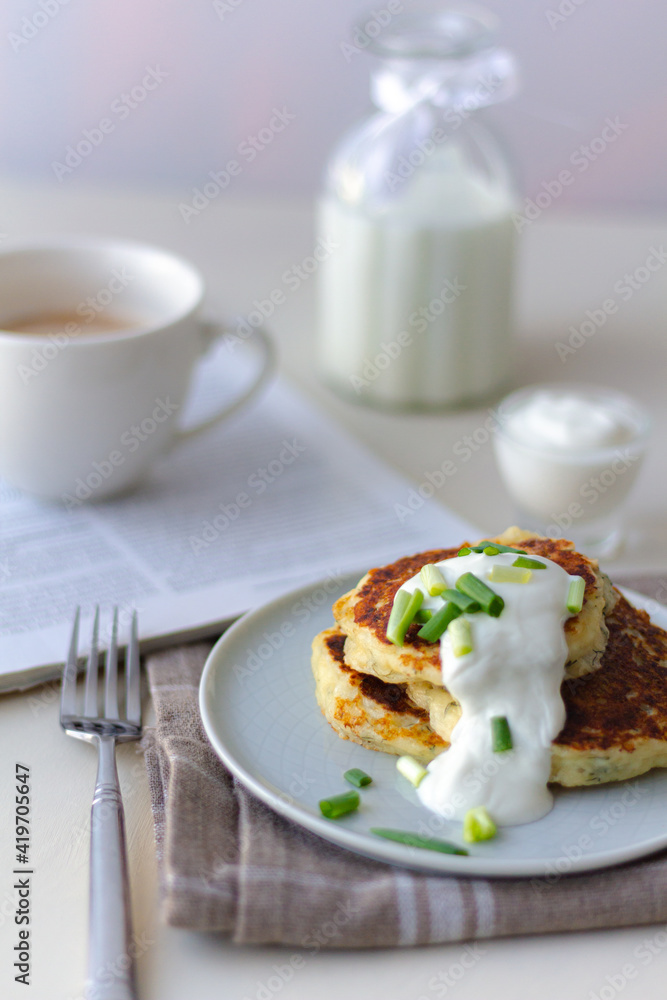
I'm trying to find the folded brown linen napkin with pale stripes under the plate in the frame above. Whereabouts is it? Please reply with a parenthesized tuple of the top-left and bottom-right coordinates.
(143, 574, 667, 944)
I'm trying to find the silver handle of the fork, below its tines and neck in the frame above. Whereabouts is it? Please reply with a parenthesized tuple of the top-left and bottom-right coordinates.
(86, 736, 137, 1000)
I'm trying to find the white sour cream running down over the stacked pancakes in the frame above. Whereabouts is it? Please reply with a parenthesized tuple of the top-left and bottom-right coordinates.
(403, 552, 572, 826)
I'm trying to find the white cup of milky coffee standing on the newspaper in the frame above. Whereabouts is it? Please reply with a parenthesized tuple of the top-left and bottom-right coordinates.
(0, 238, 274, 500)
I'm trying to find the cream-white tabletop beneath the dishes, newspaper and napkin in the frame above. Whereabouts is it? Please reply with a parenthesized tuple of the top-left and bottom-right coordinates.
(0, 183, 667, 1000)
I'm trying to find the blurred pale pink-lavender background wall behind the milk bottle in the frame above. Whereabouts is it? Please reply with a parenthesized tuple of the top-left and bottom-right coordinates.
(0, 0, 667, 214)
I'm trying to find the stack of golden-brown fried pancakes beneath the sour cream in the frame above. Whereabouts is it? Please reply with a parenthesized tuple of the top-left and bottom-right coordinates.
(312, 528, 667, 785)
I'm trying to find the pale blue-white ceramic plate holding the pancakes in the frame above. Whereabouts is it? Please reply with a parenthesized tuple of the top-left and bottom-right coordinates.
(200, 573, 667, 880)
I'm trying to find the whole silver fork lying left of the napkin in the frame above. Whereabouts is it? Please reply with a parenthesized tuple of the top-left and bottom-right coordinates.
(60, 607, 141, 1000)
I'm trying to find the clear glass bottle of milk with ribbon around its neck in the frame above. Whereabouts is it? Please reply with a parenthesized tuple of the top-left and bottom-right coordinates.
(318, 6, 516, 410)
